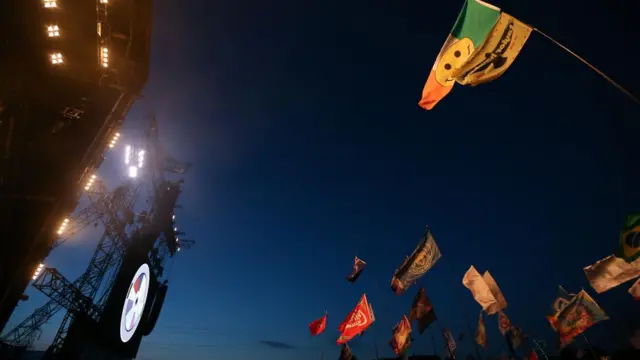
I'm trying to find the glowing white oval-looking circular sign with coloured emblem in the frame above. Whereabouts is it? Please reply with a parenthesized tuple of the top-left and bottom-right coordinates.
(120, 264, 151, 343)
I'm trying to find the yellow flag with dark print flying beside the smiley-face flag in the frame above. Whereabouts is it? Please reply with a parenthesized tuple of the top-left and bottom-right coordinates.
(453, 12, 532, 86)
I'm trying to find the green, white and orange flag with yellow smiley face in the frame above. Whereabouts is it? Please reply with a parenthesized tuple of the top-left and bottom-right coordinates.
(419, 0, 500, 110)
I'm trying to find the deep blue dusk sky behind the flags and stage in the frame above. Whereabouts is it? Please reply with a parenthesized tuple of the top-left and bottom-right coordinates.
(9, 0, 640, 360)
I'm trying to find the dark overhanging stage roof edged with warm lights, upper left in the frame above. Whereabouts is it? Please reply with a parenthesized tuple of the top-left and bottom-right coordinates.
(0, 0, 153, 332)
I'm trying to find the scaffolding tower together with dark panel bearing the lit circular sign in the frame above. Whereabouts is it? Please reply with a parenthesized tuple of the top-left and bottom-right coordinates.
(2, 116, 194, 360)
